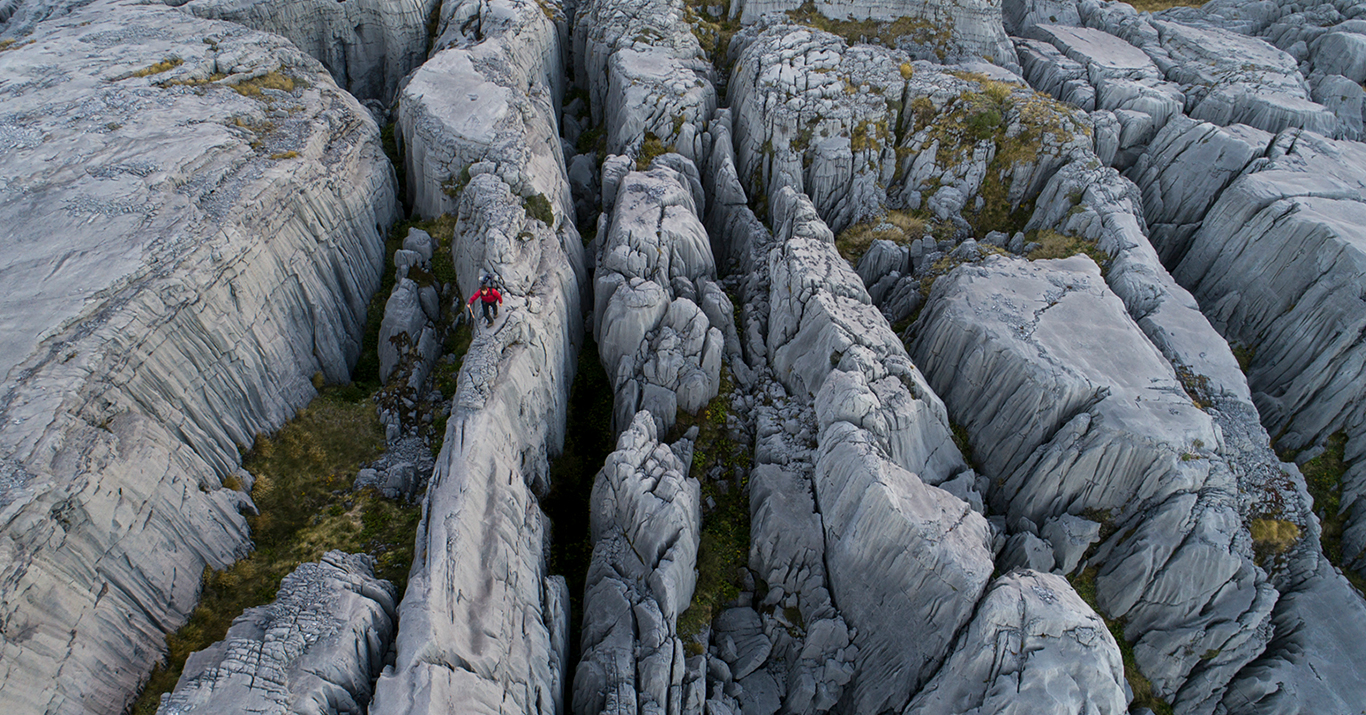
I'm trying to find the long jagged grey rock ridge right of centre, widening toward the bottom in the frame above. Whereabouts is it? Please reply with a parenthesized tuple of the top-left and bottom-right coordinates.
(766, 187, 992, 712)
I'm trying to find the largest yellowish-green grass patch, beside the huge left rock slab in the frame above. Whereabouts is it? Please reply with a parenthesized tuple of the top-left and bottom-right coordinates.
(131, 386, 421, 715)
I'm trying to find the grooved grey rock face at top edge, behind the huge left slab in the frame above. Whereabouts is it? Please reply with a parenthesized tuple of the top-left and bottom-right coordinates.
(172, 0, 437, 107)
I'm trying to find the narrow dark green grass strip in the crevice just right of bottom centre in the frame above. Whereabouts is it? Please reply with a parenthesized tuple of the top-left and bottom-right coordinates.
(669, 369, 750, 656)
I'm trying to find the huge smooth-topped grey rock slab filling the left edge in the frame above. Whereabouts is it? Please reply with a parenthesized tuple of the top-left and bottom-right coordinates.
(0, 1, 395, 712)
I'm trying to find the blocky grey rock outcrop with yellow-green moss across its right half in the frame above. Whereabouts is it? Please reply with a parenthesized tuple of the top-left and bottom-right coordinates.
(732, 26, 1091, 239)
